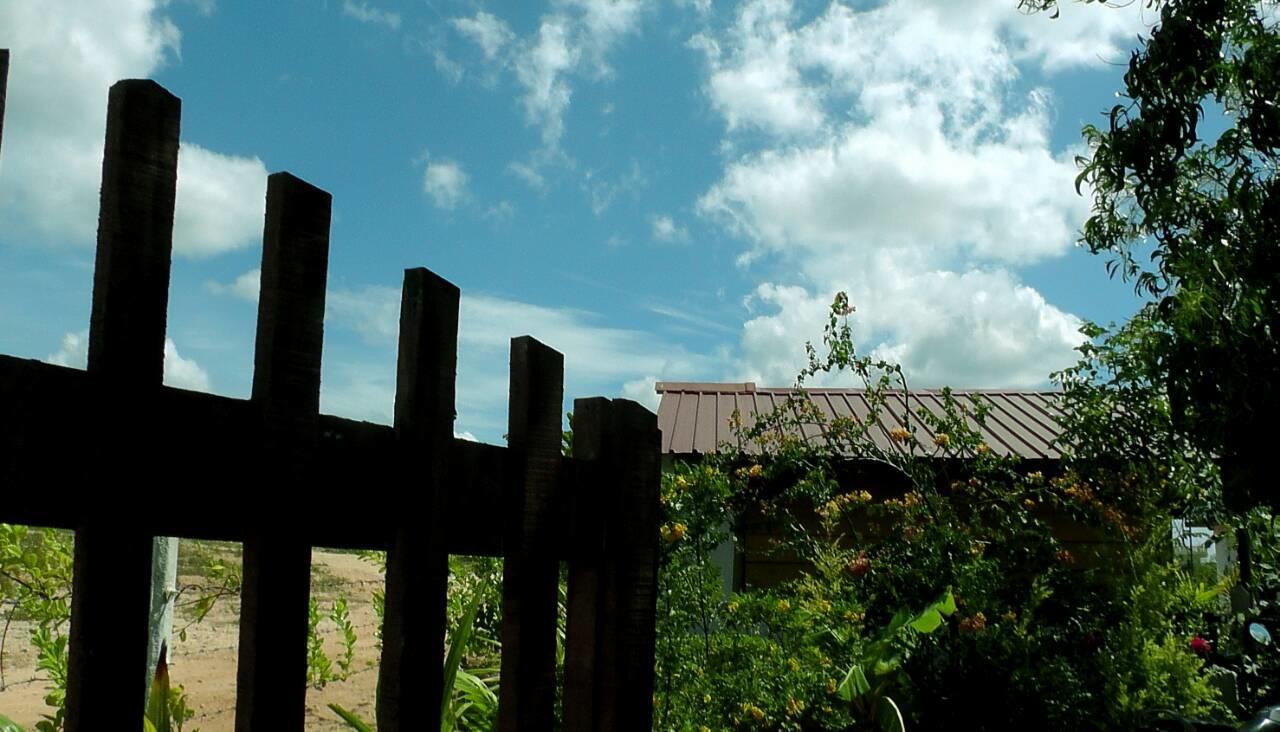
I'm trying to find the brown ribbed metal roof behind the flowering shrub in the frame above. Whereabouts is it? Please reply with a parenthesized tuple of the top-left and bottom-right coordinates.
(657, 381, 1061, 459)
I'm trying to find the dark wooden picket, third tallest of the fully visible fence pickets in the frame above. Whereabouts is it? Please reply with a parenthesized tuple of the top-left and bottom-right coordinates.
(378, 269, 460, 732)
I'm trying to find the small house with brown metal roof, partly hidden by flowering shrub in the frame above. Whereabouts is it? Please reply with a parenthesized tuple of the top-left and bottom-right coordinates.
(657, 381, 1080, 591)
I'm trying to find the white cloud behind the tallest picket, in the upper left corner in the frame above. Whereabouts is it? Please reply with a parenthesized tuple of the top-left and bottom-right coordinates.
(0, 0, 266, 257)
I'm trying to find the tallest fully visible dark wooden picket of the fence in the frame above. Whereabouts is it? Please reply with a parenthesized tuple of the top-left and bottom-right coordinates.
(67, 79, 182, 732)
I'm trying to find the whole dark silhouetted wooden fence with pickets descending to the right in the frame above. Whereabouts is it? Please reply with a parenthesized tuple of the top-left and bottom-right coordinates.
(0, 68, 660, 732)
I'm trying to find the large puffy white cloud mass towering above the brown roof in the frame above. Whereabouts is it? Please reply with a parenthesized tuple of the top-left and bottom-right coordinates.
(690, 0, 1146, 386)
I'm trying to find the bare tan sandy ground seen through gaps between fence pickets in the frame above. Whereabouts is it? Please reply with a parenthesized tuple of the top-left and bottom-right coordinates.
(0, 549, 383, 732)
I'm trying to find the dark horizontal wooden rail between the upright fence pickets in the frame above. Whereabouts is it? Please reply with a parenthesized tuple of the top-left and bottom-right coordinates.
(0, 356, 519, 547)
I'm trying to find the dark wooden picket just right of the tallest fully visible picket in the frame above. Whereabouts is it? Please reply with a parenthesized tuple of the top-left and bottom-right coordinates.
(236, 173, 333, 732)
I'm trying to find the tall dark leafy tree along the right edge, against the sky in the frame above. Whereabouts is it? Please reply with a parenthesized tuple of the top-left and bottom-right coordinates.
(1020, 0, 1280, 509)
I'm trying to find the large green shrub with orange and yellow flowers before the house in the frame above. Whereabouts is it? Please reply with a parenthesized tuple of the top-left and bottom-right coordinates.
(654, 298, 1230, 729)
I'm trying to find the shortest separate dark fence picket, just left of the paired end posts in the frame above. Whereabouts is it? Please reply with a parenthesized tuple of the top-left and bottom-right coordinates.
(498, 337, 564, 732)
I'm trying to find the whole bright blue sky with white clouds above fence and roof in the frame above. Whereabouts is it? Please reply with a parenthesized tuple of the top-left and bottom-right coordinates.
(0, 0, 1151, 442)
